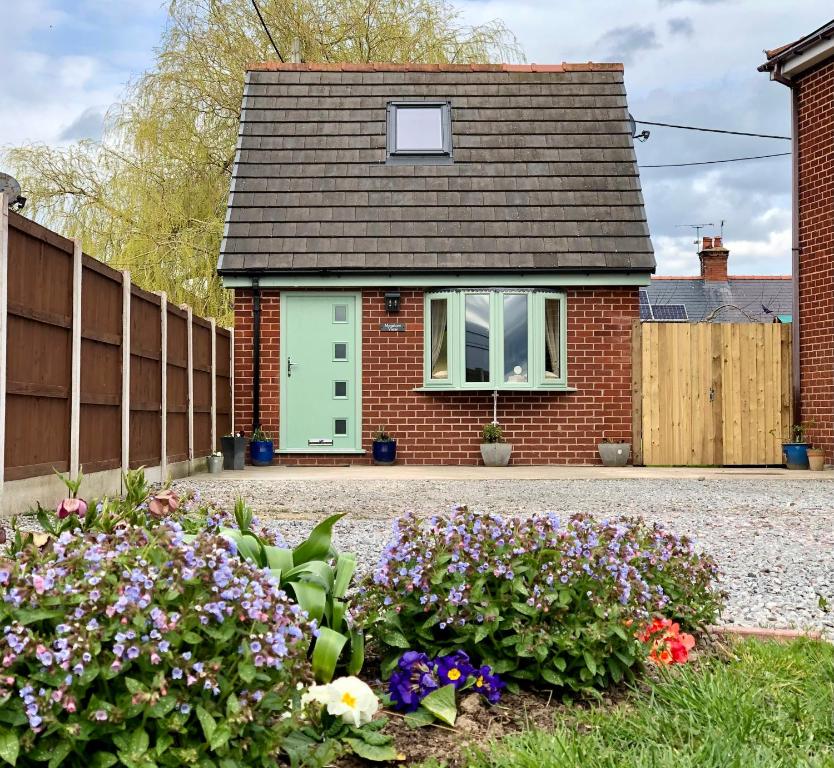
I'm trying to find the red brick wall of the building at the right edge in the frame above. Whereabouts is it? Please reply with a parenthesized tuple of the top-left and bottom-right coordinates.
(797, 62, 834, 462)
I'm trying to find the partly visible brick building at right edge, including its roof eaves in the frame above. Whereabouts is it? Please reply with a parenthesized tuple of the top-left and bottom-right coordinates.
(759, 20, 834, 463)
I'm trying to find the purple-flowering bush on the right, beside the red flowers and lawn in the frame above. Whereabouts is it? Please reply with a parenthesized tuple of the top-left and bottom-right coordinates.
(360, 508, 722, 690)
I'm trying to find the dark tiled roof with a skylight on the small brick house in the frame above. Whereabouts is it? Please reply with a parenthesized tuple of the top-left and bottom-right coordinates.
(218, 65, 655, 274)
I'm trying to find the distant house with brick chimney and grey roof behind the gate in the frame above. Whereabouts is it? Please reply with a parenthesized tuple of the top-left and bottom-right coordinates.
(640, 237, 793, 323)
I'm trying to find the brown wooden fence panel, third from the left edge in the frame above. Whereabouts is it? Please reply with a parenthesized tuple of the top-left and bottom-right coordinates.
(130, 287, 162, 468)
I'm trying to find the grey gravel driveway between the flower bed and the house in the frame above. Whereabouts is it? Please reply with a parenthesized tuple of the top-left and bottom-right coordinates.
(176, 475, 834, 634)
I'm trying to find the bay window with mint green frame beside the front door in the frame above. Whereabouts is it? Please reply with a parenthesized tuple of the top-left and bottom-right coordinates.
(424, 289, 567, 389)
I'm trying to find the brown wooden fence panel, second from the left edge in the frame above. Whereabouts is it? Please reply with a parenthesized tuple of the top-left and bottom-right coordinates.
(79, 256, 122, 474)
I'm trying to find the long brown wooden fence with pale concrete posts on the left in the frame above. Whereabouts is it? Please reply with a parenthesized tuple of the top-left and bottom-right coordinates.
(0, 199, 232, 507)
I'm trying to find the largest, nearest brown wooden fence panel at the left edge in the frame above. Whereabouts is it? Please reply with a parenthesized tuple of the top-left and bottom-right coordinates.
(4, 214, 73, 480)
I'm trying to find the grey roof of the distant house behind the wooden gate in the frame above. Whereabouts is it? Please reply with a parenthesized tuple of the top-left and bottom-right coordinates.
(645, 276, 793, 323)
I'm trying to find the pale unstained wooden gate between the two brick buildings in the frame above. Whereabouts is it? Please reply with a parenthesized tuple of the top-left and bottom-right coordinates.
(633, 323, 792, 466)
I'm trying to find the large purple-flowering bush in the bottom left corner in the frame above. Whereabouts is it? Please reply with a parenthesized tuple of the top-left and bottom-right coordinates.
(0, 522, 315, 768)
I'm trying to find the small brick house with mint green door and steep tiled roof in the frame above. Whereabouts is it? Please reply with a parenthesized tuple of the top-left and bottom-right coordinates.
(218, 64, 655, 464)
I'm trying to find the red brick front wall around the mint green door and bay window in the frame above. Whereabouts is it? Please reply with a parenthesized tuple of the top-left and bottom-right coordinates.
(235, 288, 639, 464)
